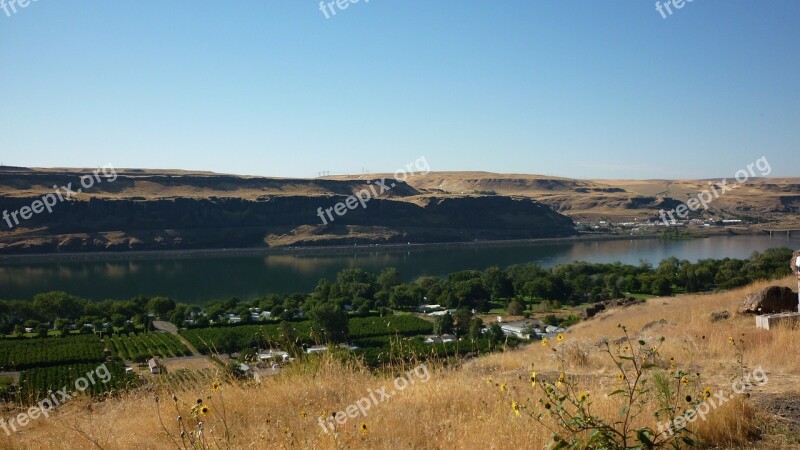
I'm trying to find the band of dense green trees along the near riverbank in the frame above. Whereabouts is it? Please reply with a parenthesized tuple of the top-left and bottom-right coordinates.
(0, 248, 792, 333)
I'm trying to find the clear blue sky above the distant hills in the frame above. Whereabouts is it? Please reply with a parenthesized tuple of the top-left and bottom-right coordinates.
(0, 0, 800, 178)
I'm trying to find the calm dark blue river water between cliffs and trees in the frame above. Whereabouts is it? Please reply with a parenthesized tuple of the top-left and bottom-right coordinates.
(0, 236, 800, 303)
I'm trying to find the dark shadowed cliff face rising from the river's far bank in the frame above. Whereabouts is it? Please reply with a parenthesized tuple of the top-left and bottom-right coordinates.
(0, 184, 575, 254)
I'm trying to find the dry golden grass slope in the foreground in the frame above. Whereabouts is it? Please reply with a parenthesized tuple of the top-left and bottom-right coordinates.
(6, 278, 800, 449)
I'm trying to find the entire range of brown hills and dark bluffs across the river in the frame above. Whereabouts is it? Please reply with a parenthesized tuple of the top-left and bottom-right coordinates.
(0, 167, 800, 254)
